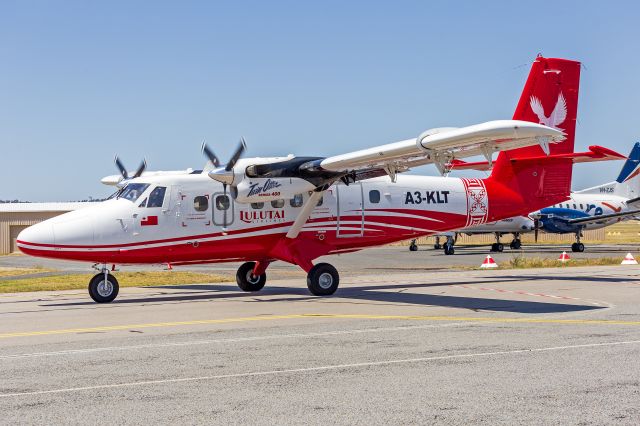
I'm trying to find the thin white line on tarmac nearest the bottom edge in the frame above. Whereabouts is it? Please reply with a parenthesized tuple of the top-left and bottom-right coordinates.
(0, 340, 640, 398)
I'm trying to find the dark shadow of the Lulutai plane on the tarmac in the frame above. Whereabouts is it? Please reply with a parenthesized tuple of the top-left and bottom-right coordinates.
(45, 277, 602, 314)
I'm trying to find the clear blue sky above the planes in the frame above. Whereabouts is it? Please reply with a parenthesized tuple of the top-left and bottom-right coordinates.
(0, 0, 640, 201)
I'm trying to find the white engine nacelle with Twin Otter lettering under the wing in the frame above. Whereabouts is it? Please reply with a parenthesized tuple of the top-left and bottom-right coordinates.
(236, 177, 315, 203)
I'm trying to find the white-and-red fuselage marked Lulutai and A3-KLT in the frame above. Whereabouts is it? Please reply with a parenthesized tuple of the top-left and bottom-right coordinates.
(18, 174, 522, 264)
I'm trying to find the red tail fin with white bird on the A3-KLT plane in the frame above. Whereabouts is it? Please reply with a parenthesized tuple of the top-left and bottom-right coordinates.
(487, 56, 580, 211)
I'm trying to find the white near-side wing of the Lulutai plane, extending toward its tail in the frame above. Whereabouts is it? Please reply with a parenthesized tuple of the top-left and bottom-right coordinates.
(319, 120, 564, 178)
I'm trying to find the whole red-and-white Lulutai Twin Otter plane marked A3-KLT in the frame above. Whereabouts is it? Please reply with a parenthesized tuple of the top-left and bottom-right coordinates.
(17, 57, 580, 303)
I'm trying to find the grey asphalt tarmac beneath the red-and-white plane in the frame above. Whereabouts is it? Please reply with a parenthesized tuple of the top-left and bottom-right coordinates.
(0, 247, 640, 424)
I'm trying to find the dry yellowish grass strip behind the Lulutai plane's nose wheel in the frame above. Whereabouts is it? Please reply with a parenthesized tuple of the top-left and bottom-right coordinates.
(0, 270, 235, 293)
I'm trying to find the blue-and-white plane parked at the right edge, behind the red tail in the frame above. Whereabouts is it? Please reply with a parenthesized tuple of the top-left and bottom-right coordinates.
(530, 142, 640, 252)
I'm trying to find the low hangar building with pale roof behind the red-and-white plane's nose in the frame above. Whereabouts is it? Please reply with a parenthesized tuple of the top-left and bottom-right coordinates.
(0, 203, 92, 255)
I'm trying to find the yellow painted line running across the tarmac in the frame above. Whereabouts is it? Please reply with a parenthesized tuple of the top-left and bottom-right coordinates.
(0, 314, 640, 339)
